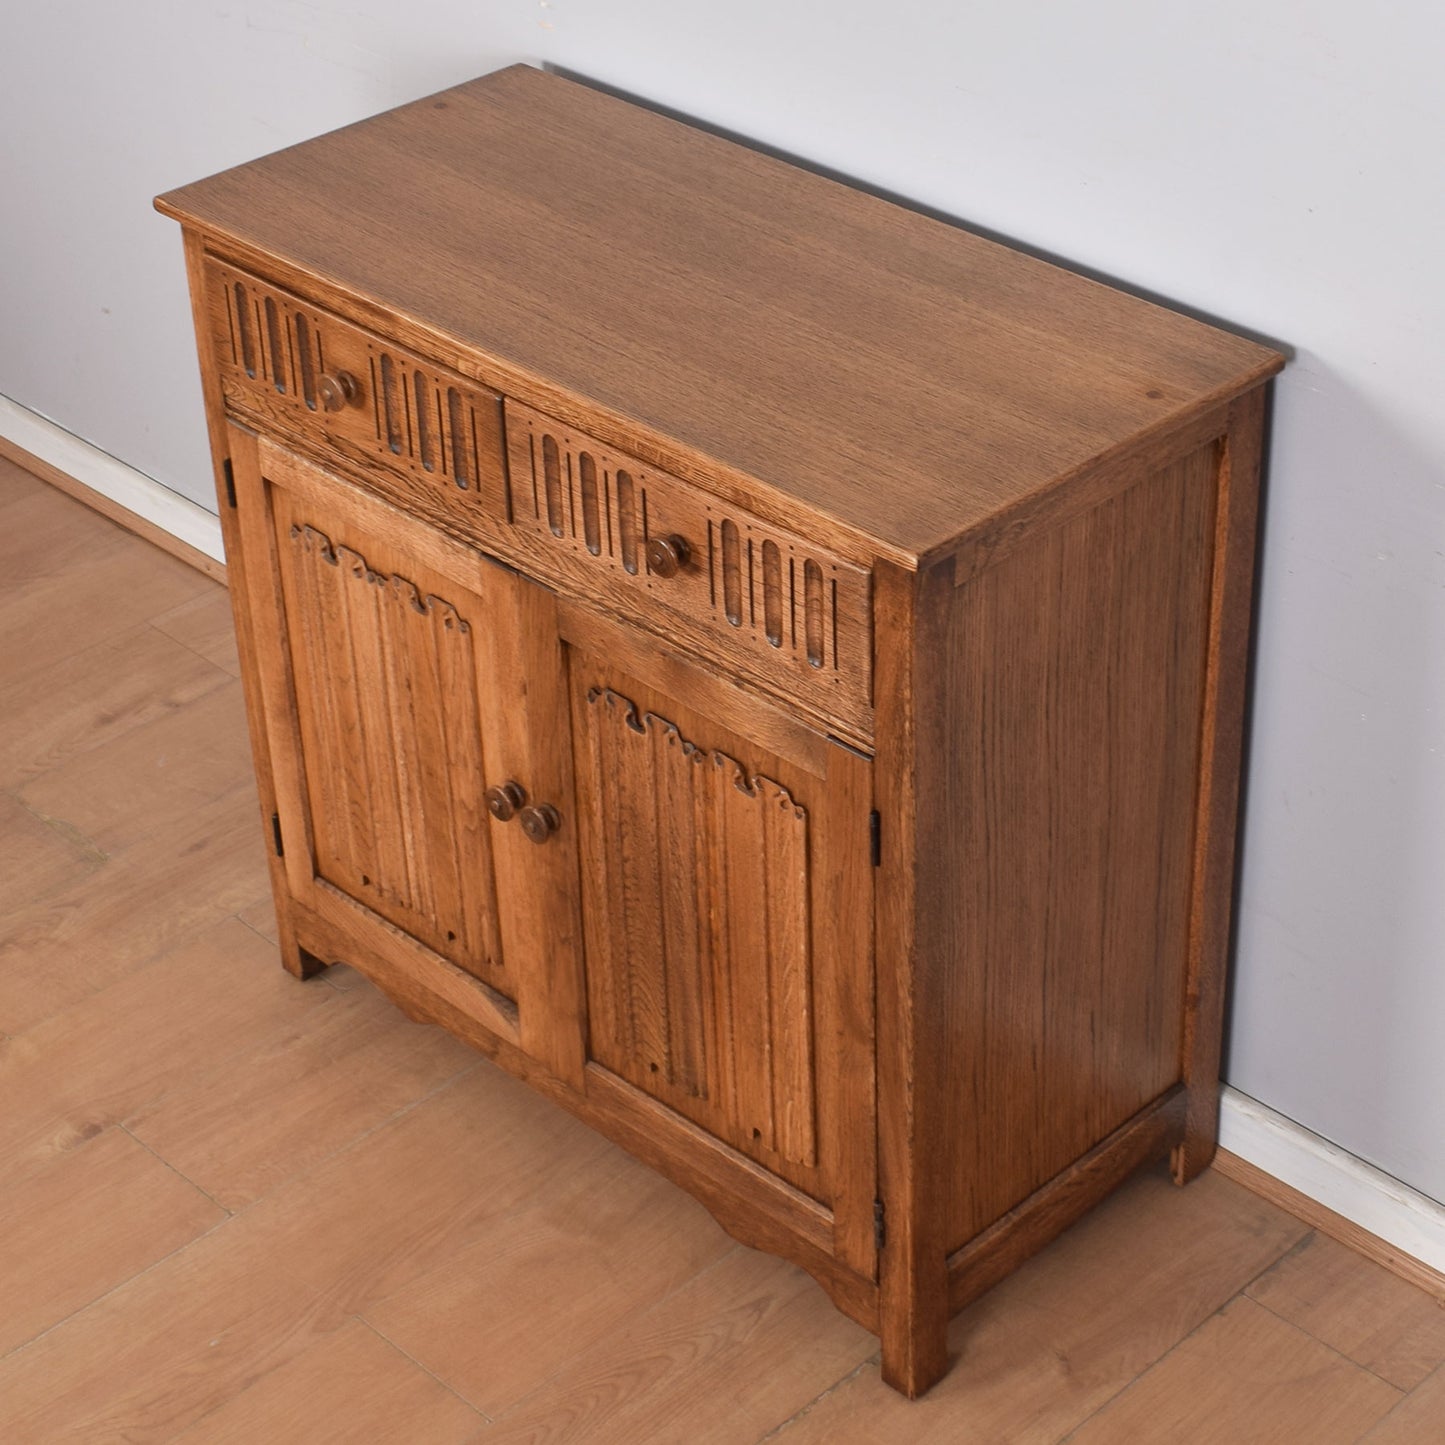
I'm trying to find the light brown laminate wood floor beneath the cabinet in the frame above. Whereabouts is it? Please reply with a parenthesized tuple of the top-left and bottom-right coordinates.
(0, 460, 1445, 1445)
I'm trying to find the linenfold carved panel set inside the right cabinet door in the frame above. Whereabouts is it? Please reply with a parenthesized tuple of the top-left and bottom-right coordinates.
(582, 688, 816, 1166)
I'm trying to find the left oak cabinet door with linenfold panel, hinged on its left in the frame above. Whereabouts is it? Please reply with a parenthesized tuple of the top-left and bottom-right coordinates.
(228, 423, 582, 1079)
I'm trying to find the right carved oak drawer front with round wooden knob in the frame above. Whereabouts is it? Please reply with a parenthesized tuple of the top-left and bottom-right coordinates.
(503, 397, 873, 741)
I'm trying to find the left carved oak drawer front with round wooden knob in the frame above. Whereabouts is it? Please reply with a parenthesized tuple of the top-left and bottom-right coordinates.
(207, 259, 504, 538)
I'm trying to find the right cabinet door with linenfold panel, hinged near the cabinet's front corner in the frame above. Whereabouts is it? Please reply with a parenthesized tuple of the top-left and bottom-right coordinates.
(564, 620, 874, 1270)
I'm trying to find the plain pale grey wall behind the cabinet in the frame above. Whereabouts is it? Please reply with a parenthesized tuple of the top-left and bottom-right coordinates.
(0, 0, 1445, 1199)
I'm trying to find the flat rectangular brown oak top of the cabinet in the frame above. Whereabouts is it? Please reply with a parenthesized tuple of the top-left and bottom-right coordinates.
(158, 65, 1282, 559)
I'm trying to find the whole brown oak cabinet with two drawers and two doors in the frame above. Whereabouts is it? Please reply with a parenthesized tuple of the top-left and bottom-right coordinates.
(158, 66, 1280, 1393)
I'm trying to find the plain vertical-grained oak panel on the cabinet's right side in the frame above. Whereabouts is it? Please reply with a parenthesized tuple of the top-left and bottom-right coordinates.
(922, 442, 1220, 1248)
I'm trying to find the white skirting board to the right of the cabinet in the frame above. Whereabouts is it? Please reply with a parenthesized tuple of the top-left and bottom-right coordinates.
(1220, 1085, 1445, 1273)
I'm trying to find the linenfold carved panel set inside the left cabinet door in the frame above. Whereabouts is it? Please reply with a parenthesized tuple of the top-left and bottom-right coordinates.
(282, 522, 510, 993)
